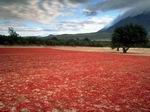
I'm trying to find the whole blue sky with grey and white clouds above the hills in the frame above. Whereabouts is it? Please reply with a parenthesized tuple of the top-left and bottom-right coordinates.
(0, 0, 150, 36)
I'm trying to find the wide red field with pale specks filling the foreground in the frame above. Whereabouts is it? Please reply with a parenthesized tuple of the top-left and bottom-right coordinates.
(0, 48, 150, 112)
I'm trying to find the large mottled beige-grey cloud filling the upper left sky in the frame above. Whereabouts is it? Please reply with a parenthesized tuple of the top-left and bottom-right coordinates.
(0, 0, 89, 23)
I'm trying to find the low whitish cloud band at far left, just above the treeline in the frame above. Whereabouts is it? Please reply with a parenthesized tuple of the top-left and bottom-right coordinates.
(0, 19, 52, 36)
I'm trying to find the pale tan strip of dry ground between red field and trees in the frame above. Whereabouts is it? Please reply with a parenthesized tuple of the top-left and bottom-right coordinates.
(0, 46, 150, 56)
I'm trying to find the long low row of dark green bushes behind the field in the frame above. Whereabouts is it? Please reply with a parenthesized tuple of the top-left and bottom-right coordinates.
(0, 35, 110, 47)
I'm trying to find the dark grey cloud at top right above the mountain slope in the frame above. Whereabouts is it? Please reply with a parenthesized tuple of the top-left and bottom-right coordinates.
(87, 0, 150, 17)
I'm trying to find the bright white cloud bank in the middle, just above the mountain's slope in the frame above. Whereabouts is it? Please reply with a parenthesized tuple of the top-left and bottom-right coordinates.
(52, 16, 114, 34)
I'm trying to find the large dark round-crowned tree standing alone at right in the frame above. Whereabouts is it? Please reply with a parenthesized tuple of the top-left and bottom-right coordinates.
(112, 24, 148, 53)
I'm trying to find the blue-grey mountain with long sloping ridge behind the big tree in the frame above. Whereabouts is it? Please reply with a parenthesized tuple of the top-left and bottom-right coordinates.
(48, 13, 150, 41)
